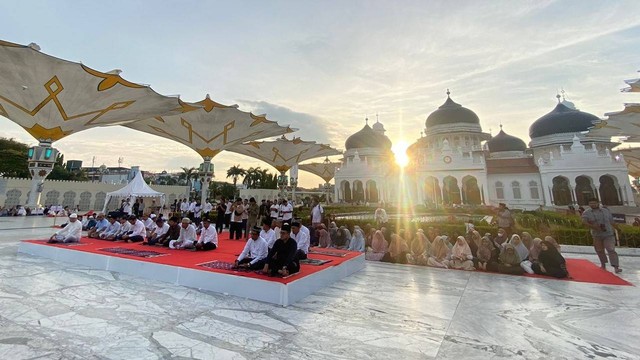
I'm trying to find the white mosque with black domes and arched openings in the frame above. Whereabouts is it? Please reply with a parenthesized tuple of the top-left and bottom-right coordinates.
(335, 91, 635, 209)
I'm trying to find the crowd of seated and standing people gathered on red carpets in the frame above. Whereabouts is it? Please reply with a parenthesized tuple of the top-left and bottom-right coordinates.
(43, 198, 621, 278)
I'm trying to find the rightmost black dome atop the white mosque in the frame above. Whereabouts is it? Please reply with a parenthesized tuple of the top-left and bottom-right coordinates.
(529, 103, 600, 139)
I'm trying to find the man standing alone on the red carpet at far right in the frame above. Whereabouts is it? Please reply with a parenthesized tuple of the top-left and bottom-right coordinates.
(582, 198, 622, 273)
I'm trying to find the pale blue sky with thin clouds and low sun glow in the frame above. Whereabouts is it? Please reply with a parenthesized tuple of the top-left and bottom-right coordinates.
(0, 0, 640, 187)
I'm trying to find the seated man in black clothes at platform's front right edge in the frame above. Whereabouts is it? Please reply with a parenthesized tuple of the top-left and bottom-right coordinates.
(262, 223, 300, 277)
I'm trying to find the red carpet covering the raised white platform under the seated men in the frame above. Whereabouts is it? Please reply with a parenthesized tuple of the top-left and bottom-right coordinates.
(24, 232, 362, 284)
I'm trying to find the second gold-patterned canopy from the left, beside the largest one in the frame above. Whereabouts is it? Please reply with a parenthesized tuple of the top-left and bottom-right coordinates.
(125, 95, 294, 159)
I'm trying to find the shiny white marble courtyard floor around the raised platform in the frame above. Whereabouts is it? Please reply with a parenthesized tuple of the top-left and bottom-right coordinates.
(0, 217, 640, 360)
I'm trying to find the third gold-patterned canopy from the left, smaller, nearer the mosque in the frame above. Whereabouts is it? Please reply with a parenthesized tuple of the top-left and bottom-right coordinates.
(227, 136, 342, 173)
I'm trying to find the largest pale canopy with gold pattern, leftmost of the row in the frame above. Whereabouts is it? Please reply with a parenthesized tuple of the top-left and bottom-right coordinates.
(0, 40, 191, 142)
